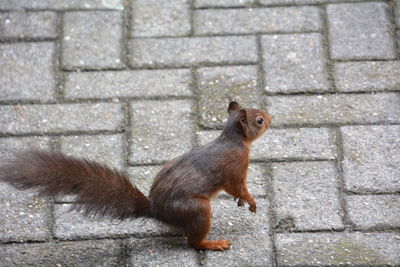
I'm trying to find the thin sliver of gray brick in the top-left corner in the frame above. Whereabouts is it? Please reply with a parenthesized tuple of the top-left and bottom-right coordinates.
(0, 0, 124, 10)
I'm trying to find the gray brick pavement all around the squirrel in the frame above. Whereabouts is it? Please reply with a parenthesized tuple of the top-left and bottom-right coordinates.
(0, 0, 400, 266)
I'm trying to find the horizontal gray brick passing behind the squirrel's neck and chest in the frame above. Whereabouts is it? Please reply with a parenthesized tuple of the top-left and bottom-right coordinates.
(196, 128, 336, 160)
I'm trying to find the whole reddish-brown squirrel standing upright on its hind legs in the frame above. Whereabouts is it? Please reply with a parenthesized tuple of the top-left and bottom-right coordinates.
(0, 101, 271, 250)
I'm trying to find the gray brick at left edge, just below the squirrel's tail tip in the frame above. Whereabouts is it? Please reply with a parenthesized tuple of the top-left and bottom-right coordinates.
(0, 199, 51, 243)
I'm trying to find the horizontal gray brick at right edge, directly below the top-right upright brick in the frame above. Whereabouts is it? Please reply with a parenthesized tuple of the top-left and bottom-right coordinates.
(335, 61, 400, 92)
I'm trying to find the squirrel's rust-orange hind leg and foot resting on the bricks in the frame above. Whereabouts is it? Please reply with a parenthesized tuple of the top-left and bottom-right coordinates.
(185, 198, 231, 250)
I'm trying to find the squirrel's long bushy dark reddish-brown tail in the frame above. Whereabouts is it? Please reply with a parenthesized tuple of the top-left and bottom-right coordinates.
(0, 150, 150, 220)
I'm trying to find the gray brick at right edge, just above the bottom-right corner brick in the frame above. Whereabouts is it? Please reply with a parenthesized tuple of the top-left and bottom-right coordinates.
(346, 195, 400, 229)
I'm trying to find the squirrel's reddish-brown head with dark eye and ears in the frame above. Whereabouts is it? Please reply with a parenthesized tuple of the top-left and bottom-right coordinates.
(228, 101, 271, 142)
